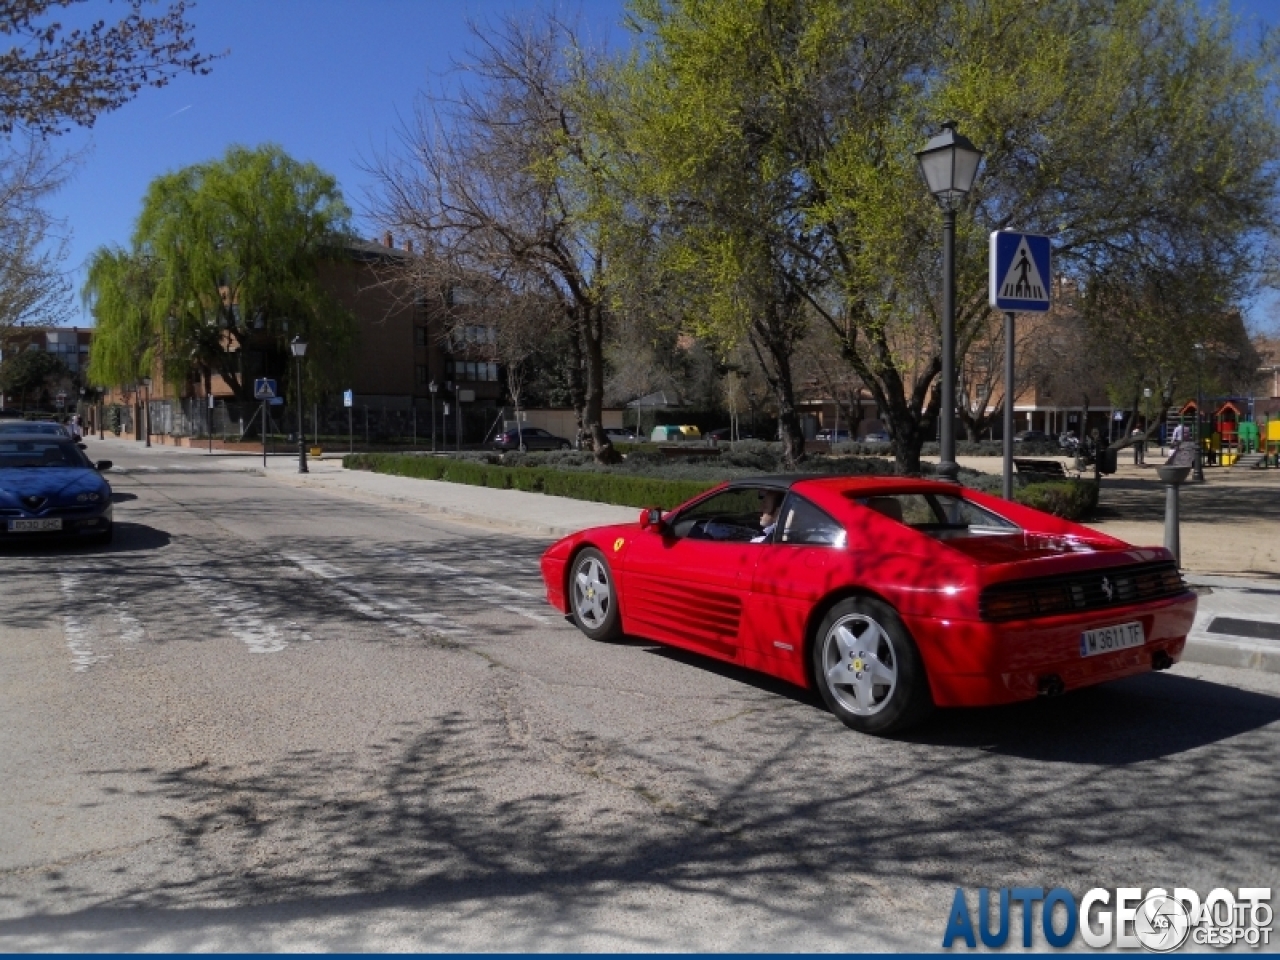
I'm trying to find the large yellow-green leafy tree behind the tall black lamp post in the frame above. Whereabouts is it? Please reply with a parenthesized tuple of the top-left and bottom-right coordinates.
(621, 0, 1280, 471)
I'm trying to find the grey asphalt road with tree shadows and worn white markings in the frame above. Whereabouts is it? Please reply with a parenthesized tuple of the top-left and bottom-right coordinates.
(0, 444, 1280, 951)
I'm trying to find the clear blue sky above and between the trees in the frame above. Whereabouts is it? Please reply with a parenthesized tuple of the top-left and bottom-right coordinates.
(37, 0, 1280, 324)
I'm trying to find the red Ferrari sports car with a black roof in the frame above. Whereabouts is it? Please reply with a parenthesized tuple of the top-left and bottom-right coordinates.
(541, 476, 1196, 733)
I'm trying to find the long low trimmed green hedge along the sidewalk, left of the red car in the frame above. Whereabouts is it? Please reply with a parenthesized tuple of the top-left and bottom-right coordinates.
(342, 453, 718, 509)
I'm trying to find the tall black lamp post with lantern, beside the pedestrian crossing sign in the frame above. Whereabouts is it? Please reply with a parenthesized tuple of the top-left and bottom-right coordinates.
(915, 120, 983, 483)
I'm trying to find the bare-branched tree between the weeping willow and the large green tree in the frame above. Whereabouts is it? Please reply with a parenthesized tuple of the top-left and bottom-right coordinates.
(369, 18, 617, 461)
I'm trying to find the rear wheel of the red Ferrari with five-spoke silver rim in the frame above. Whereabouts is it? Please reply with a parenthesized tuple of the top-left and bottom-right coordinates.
(813, 596, 933, 733)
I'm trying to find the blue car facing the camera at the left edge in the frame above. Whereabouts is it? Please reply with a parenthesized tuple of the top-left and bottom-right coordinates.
(0, 433, 113, 544)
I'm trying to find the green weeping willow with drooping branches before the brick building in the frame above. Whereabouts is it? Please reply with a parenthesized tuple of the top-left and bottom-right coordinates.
(83, 146, 355, 402)
